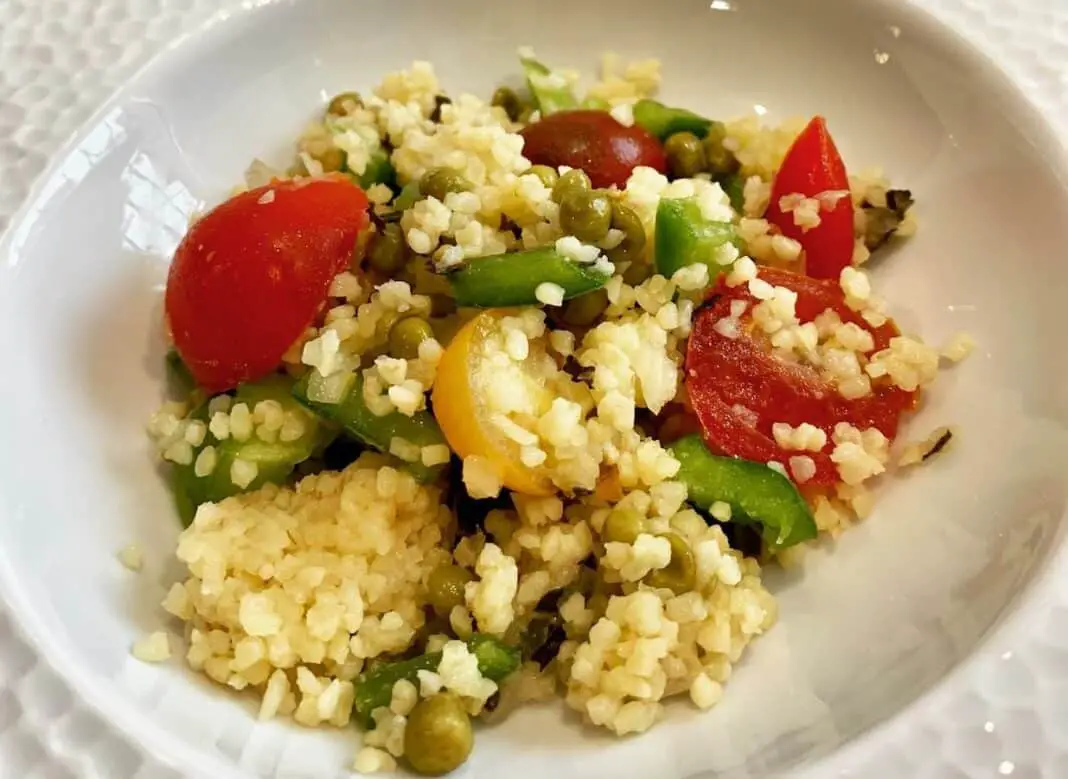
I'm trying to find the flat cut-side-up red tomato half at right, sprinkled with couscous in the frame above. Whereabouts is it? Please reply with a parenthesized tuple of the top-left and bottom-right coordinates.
(686, 268, 917, 485)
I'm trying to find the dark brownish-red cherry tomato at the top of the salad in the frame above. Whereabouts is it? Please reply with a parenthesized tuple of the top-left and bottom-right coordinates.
(520, 110, 668, 189)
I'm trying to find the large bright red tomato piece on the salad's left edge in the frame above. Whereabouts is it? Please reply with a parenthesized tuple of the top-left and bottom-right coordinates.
(166, 176, 370, 392)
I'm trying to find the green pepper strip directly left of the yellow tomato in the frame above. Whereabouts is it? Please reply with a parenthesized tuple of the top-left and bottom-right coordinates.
(293, 372, 445, 482)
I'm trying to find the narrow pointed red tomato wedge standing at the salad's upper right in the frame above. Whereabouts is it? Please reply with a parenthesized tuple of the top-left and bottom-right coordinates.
(765, 116, 854, 279)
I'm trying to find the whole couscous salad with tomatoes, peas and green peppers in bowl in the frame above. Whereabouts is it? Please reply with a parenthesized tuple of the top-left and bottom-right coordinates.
(137, 50, 972, 774)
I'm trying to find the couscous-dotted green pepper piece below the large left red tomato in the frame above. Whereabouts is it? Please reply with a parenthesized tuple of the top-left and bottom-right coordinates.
(171, 376, 320, 525)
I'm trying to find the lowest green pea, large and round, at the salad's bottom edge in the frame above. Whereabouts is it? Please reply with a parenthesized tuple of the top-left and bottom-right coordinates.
(404, 694, 474, 776)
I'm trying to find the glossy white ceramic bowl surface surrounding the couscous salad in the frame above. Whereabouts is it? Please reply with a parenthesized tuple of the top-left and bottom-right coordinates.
(0, 0, 1068, 778)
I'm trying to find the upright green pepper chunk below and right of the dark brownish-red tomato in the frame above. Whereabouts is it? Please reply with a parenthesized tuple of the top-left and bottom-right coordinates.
(656, 198, 741, 283)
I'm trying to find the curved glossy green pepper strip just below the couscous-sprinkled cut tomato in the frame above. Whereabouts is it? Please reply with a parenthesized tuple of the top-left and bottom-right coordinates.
(668, 434, 816, 551)
